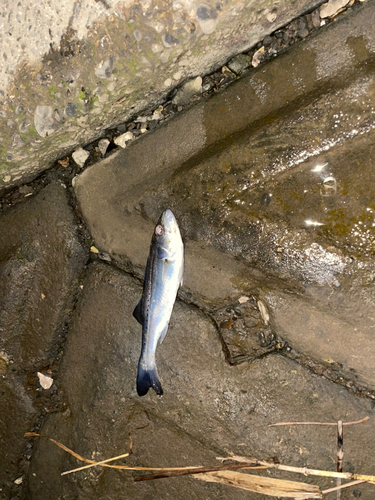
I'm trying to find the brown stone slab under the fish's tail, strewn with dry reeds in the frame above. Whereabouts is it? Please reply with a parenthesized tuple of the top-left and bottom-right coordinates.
(24, 264, 375, 500)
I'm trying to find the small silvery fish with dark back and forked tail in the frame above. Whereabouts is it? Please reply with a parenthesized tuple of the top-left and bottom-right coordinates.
(133, 209, 184, 396)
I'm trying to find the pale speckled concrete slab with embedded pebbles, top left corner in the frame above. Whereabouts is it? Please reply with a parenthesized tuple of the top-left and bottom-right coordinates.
(0, 0, 320, 190)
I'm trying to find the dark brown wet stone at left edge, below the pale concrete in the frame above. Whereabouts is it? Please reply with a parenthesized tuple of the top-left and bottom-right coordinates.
(0, 184, 86, 498)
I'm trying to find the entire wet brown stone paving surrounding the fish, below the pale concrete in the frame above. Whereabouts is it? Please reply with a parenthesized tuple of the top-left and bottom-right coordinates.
(0, 0, 375, 500)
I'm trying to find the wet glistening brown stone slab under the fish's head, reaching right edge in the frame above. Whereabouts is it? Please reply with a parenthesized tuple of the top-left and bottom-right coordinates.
(75, 4, 375, 389)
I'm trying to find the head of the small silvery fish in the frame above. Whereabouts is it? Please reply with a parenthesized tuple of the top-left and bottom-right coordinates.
(153, 208, 183, 259)
